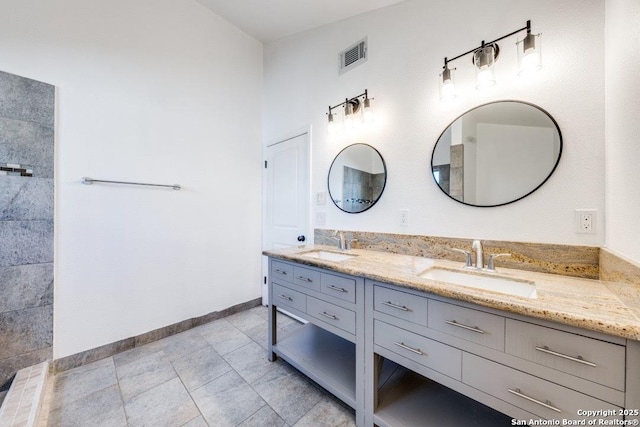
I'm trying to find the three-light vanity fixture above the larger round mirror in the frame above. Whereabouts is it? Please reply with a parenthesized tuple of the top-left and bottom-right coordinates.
(440, 20, 542, 101)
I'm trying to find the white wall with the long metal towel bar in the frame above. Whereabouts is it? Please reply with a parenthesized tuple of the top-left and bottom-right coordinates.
(0, 0, 262, 358)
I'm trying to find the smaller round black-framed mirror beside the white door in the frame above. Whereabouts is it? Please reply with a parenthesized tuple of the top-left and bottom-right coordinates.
(328, 144, 387, 213)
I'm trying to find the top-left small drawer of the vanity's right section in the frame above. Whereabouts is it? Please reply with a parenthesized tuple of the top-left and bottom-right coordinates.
(373, 285, 428, 326)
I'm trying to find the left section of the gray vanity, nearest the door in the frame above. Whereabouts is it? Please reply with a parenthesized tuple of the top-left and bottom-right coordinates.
(268, 258, 365, 426)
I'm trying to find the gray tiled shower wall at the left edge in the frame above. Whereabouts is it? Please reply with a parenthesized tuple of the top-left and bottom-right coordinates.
(0, 71, 55, 387)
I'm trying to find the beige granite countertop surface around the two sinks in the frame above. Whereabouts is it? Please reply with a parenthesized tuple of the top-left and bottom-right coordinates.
(263, 245, 640, 341)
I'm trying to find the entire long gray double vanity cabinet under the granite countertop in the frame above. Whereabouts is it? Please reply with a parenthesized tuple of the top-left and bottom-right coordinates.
(268, 258, 640, 427)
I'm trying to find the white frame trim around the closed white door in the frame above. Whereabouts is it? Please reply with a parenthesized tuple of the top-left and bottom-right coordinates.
(260, 125, 314, 305)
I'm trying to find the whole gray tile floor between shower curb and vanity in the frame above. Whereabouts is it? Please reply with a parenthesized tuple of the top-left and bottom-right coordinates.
(40, 307, 355, 427)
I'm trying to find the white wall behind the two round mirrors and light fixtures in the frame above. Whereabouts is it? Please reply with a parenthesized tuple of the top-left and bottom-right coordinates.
(264, 0, 605, 245)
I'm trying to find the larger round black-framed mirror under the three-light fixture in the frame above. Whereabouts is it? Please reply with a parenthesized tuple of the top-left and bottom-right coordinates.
(431, 101, 562, 207)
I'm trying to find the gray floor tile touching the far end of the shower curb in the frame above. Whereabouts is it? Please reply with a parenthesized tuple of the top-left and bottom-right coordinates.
(51, 357, 118, 408)
